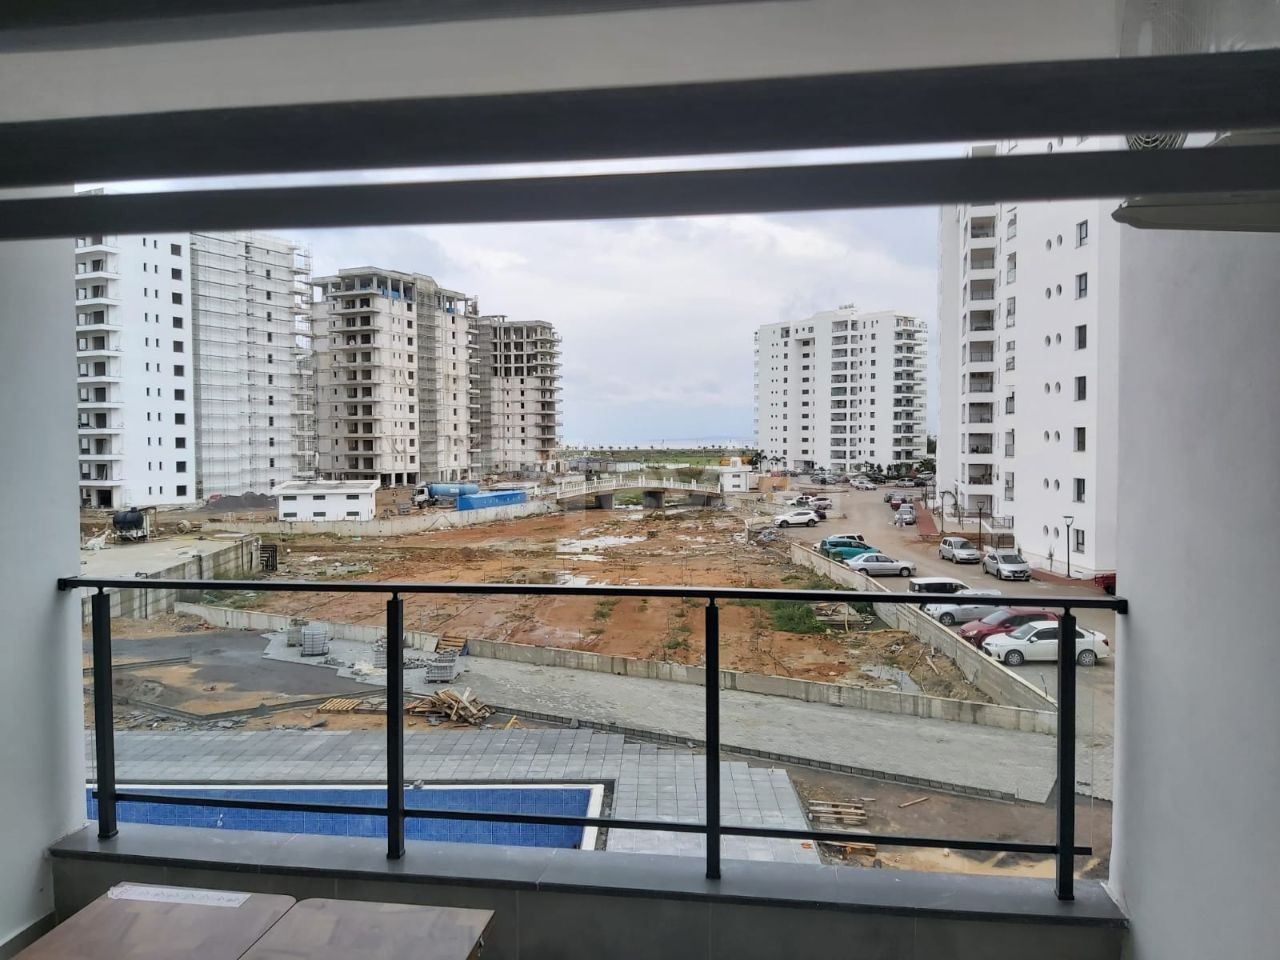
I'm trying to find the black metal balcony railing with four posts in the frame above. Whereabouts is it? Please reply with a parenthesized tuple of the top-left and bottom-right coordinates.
(58, 577, 1128, 900)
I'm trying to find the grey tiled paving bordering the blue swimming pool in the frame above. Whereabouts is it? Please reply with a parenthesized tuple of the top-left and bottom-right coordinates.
(84, 730, 818, 863)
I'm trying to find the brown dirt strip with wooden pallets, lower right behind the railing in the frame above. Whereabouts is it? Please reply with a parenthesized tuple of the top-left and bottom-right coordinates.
(786, 767, 1111, 878)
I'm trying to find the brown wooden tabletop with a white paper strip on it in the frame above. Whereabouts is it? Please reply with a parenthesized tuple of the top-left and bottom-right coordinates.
(15, 883, 294, 960)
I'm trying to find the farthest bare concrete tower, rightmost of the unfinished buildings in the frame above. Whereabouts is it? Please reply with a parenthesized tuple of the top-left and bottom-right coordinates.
(471, 315, 563, 474)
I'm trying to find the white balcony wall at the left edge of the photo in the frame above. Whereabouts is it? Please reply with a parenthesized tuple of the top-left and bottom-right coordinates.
(0, 200, 84, 952)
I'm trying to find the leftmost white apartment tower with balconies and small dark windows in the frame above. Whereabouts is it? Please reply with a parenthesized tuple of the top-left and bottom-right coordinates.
(74, 234, 197, 509)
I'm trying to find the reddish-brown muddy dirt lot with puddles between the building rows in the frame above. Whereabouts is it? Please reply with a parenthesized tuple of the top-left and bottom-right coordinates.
(227, 511, 986, 700)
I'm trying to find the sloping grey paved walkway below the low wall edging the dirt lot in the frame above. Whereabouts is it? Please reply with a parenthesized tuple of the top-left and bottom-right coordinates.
(440, 657, 1070, 803)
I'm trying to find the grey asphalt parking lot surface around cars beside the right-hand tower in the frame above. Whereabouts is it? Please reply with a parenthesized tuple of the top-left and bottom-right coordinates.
(785, 485, 1119, 746)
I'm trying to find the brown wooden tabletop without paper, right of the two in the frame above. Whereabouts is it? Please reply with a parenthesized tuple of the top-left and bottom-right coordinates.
(244, 900, 493, 960)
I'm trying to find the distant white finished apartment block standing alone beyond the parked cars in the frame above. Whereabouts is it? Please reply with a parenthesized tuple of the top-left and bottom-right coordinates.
(753, 305, 928, 471)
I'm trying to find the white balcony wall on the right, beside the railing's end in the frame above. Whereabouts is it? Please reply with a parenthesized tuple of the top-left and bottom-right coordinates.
(1111, 230, 1280, 960)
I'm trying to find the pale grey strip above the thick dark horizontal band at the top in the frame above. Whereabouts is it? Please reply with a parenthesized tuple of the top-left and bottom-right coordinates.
(0, 0, 1116, 122)
